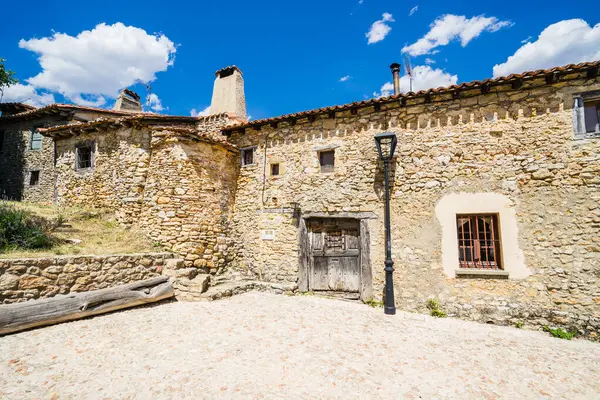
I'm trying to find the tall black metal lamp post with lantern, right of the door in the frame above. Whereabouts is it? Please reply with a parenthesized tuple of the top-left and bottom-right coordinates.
(375, 132, 398, 315)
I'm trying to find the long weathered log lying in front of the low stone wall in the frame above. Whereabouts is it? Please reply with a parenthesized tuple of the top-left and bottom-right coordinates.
(0, 276, 174, 335)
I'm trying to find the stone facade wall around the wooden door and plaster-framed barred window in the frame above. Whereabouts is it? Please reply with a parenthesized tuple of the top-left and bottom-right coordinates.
(231, 77, 600, 337)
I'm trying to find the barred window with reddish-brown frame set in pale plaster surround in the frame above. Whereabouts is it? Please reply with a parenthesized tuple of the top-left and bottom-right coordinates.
(456, 214, 502, 269)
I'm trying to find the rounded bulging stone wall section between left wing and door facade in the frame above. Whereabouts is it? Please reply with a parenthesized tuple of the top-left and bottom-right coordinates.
(140, 130, 238, 273)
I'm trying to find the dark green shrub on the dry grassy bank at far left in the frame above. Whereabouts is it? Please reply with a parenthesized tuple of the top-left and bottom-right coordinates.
(0, 204, 62, 252)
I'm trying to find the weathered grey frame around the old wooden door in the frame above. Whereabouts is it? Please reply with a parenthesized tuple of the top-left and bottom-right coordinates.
(298, 212, 376, 301)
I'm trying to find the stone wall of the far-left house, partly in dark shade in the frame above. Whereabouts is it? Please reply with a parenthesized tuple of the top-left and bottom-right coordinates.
(0, 116, 66, 203)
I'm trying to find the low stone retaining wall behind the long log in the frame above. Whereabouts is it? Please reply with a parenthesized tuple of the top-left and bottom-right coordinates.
(0, 253, 173, 304)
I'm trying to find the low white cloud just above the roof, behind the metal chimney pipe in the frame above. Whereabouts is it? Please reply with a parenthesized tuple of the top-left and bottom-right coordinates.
(373, 65, 458, 97)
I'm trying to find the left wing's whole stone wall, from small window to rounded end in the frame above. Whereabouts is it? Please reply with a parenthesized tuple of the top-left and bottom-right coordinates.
(51, 114, 238, 273)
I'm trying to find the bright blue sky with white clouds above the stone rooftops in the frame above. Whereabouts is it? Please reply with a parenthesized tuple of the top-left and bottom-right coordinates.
(0, 0, 600, 119)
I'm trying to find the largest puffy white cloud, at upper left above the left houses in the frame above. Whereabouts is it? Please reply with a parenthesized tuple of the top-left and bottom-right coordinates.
(19, 22, 176, 105)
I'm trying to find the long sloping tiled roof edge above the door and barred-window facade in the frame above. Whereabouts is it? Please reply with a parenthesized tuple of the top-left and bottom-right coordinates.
(223, 60, 600, 132)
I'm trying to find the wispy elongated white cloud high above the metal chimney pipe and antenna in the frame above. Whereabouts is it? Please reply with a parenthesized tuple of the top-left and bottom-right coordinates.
(402, 14, 512, 56)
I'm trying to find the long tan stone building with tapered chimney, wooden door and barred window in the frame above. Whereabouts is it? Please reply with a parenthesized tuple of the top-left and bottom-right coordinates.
(0, 61, 600, 337)
